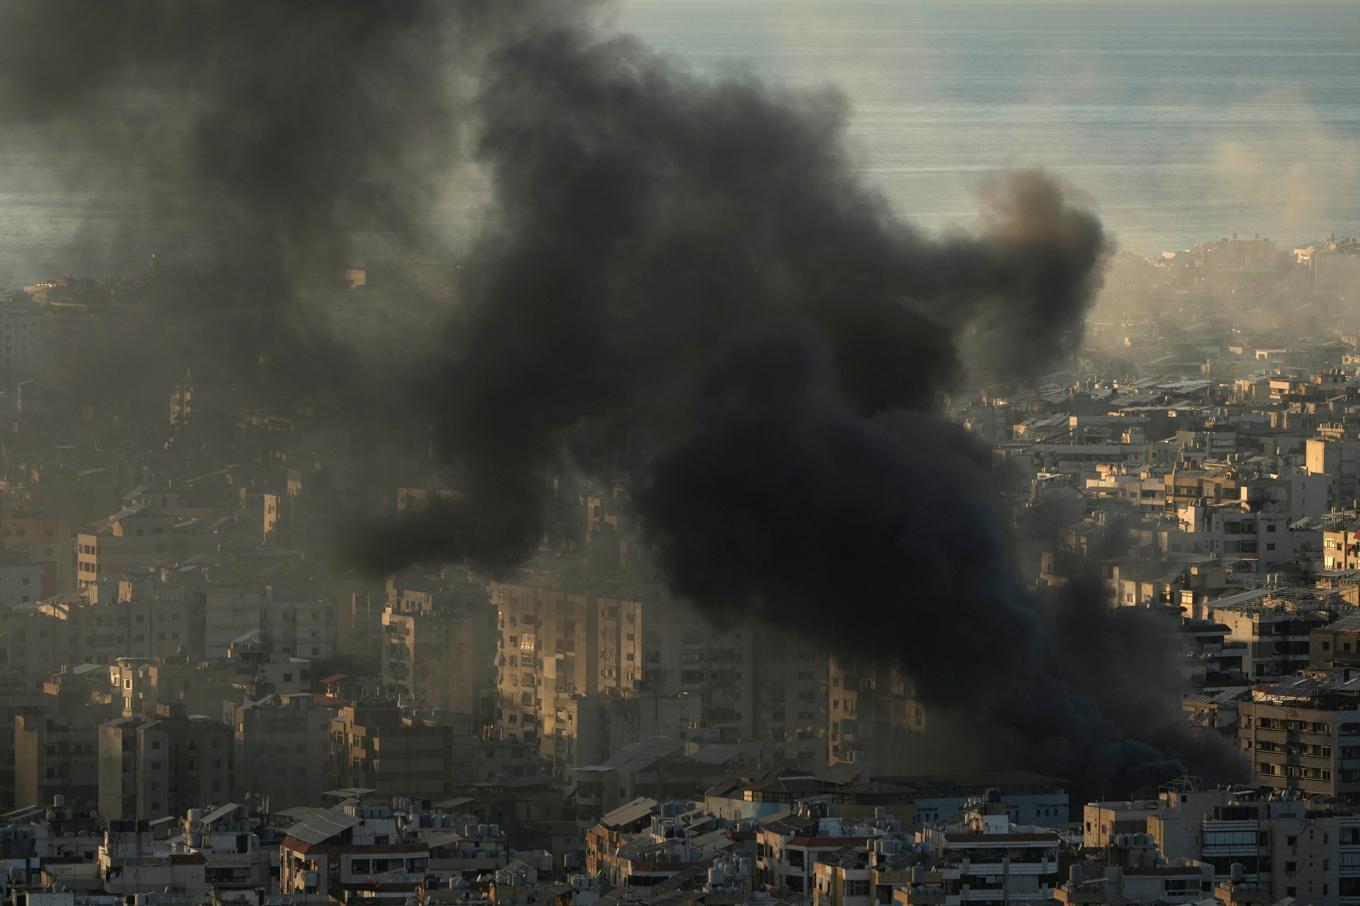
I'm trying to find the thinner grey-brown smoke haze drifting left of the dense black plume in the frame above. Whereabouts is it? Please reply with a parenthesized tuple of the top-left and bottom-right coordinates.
(0, 0, 574, 403)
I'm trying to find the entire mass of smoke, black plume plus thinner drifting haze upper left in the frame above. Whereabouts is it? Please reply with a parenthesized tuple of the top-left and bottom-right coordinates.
(0, 0, 1231, 792)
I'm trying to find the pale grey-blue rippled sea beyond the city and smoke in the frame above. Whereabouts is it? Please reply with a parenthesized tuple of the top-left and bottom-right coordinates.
(0, 0, 1360, 287)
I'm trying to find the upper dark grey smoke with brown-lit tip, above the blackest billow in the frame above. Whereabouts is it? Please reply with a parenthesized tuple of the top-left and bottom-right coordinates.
(379, 30, 1104, 560)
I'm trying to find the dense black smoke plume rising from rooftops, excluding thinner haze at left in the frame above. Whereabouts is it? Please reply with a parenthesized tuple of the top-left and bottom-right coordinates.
(383, 12, 1231, 792)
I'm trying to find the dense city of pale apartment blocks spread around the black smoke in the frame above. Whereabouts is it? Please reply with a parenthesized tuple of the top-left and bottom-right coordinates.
(0, 235, 1360, 906)
